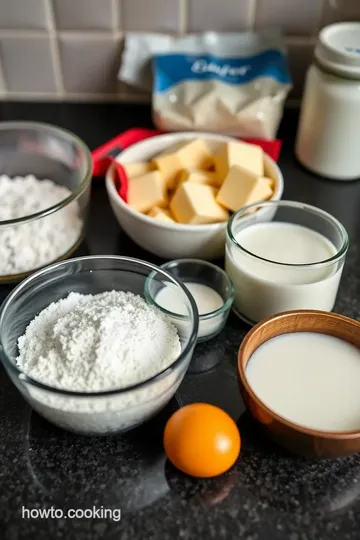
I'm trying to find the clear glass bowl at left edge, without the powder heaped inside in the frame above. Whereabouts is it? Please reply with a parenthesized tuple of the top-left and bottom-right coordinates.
(0, 122, 92, 284)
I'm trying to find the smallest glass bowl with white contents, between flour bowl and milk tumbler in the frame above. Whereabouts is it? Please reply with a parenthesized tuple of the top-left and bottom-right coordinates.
(145, 259, 234, 343)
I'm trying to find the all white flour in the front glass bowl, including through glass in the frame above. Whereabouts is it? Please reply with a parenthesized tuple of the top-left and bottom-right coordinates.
(16, 291, 183, 434)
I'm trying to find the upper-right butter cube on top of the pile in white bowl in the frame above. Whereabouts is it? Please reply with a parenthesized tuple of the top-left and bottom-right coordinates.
(214, 141, 264, 185)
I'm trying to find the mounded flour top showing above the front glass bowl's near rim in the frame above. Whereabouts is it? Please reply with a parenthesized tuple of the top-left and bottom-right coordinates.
(17, 291, 181, 392)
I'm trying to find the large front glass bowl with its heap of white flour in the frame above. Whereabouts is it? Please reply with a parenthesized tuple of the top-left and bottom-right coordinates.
(0, 256, 198, 435)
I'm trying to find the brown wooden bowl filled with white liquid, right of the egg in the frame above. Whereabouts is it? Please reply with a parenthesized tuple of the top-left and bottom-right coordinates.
(238, 310, 360, 457)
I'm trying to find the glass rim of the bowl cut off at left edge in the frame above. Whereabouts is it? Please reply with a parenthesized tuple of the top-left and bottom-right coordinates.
(0, 122, 92, 228)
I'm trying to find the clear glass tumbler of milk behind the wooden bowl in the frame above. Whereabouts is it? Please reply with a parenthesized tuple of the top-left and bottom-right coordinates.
(225, 201, 349, 325)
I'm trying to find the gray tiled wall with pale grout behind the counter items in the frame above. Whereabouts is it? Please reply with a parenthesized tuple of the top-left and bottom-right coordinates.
(0, 0, 360, 101)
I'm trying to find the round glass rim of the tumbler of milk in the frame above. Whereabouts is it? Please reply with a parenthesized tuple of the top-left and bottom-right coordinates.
(226, 200, 349, 268)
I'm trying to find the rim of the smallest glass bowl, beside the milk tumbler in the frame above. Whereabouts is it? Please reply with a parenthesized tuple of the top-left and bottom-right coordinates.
(145, 259, 235, 321)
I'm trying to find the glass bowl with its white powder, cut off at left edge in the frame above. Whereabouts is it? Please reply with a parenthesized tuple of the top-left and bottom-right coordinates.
(0, 122, 92, 283)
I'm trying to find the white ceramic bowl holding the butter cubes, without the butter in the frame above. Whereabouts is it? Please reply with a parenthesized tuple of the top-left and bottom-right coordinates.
(106, 132, 284, 260)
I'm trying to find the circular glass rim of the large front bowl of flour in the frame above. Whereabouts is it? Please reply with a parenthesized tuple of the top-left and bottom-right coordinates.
(0, 255, 199, 398)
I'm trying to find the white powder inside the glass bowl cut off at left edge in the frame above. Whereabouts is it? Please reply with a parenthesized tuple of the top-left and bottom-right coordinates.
(0, 175, 83, 276)
